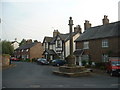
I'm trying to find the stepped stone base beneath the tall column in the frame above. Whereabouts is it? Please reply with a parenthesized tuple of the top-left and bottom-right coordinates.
(53, 66, 90, 77)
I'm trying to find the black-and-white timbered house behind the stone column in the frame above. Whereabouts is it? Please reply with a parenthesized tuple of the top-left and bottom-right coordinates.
(43, 25, 81, 60)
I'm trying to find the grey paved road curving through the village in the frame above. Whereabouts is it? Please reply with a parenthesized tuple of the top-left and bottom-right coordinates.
(2, 62, 119, 88)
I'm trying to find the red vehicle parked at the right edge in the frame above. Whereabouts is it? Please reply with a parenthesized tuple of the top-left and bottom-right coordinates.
(106, 57, 120, 76)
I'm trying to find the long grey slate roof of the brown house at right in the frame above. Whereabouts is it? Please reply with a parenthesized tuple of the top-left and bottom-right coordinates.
(75, 21, 120, 42)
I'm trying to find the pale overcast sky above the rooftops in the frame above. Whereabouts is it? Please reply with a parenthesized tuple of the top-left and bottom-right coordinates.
(0, 0, 120, 42)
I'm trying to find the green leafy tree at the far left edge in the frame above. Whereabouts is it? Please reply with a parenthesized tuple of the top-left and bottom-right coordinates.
(0, 40, 14, 55)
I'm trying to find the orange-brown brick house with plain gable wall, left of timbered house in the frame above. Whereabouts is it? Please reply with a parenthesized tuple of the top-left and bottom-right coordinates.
(14, 40, 43, 59)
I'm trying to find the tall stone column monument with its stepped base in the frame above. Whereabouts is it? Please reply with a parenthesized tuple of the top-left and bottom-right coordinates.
(53, 17, 90, 77)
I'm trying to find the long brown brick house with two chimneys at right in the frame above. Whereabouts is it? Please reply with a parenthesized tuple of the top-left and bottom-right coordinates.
(74, 15, 120, 65)
